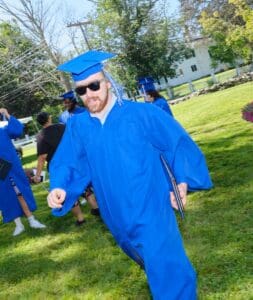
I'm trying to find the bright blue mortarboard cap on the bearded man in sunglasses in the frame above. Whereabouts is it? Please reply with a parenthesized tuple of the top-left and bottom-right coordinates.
(57, 50, 115, 81)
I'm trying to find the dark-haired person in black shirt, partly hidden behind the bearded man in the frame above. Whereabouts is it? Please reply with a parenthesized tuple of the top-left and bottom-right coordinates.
(33, 112, 98, 225)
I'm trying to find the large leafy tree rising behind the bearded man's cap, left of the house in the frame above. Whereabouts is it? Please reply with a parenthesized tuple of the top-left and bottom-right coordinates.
(86, 0, 183, 91)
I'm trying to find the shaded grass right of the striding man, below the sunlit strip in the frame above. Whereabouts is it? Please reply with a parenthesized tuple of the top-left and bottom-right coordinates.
(180, 131, 253, 299)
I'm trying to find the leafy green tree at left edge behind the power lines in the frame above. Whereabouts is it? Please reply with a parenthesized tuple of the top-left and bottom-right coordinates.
(0, 22, 58, 117)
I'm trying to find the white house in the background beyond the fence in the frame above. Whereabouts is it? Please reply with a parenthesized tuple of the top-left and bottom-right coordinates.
(155, 38, 228, 90)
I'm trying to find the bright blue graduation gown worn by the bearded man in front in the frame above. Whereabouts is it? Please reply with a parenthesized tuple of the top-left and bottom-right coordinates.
(50, 101, 212, 300)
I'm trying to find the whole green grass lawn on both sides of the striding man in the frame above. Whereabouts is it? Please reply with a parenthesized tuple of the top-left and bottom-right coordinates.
(0, 83, 253, 300)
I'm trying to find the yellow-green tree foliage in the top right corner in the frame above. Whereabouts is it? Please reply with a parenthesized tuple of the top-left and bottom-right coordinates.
(200, 0, 253, 65)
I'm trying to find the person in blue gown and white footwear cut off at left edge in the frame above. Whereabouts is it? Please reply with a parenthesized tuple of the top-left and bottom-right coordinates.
(0, 108, 46, 236)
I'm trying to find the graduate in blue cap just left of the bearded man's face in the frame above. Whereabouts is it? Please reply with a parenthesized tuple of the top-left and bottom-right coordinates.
(59, 90, 85, 124)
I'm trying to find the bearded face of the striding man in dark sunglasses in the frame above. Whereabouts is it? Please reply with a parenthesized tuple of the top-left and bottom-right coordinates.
(76, 72, 111, 113)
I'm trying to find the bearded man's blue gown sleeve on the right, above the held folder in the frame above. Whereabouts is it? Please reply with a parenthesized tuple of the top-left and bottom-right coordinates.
(144, 106, 212, 191)
